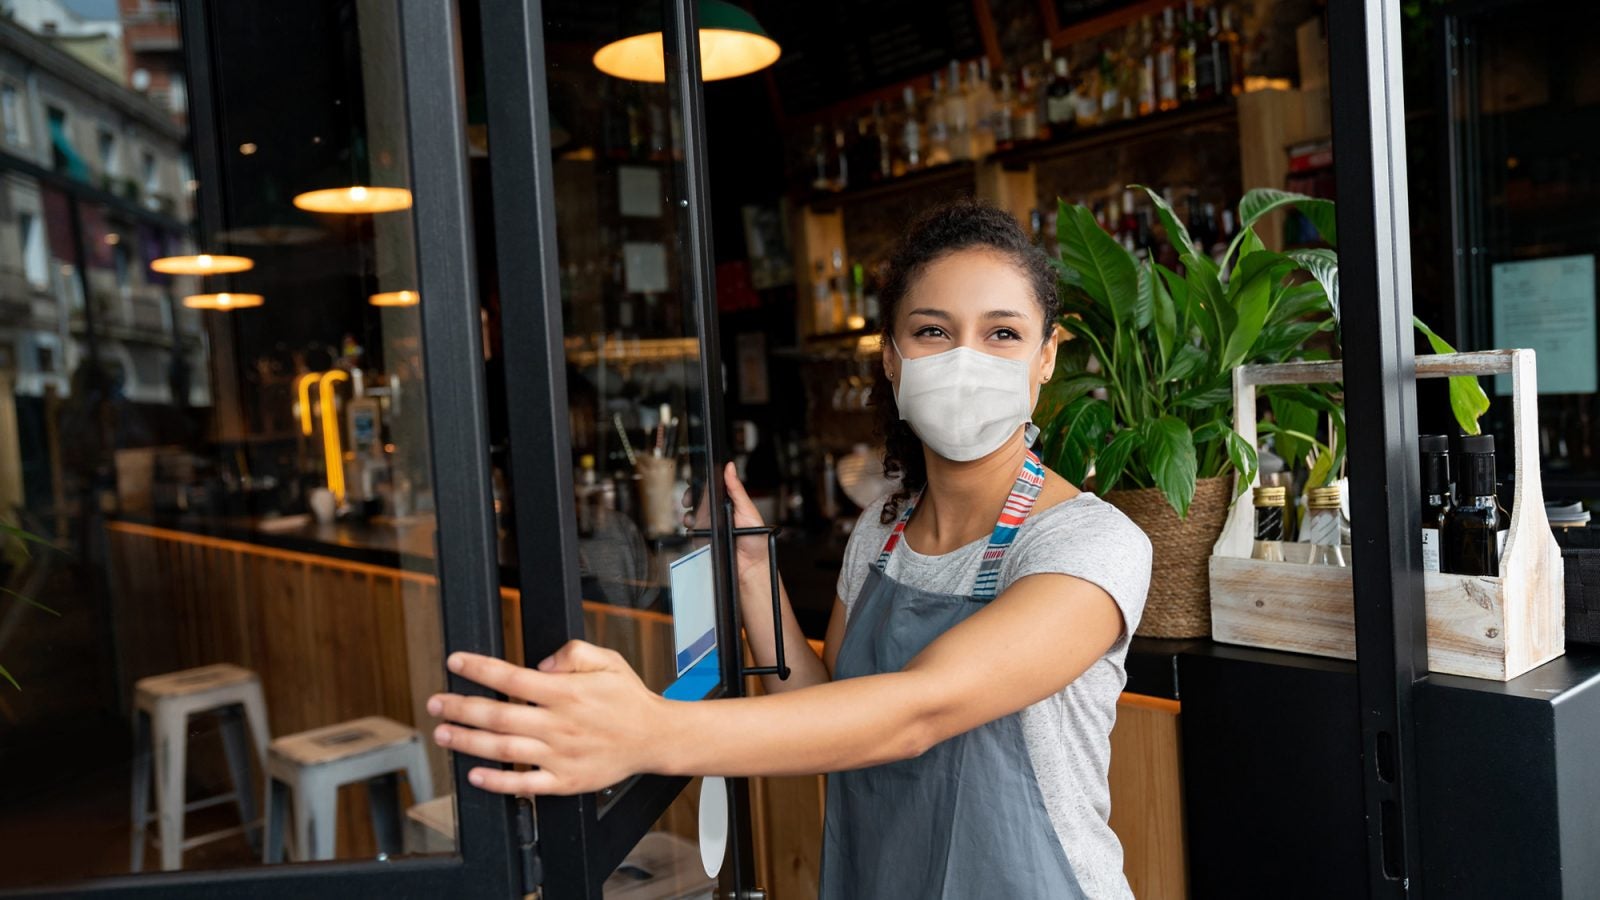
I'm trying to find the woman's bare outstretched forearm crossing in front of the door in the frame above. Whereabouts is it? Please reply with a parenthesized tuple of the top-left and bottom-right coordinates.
(658, 669, 938, 777)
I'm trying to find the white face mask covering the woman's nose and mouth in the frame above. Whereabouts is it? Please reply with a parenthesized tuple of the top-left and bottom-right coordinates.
(891, 341, 1034, 463)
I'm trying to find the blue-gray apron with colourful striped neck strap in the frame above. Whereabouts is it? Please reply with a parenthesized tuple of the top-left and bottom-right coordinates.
(821, 453, 1083, 900)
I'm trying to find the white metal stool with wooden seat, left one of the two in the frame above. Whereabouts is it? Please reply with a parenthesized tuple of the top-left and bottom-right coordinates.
(131, 663, 267, 871)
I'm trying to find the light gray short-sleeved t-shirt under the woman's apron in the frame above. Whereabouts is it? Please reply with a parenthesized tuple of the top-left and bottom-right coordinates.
(838, 493, 1150, 900)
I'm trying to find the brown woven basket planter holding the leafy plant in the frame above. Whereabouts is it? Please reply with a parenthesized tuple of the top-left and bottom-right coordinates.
(1106, 474, 1234, 637)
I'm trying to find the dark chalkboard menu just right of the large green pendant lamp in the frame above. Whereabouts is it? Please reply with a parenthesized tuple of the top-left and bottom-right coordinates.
(754, 0, 984, 115)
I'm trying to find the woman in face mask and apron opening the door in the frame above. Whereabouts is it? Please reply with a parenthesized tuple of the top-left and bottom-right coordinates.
(429, 202, 1150, 898)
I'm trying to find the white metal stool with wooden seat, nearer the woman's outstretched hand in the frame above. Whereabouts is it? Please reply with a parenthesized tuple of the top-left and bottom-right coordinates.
(262, 716, 434, 863)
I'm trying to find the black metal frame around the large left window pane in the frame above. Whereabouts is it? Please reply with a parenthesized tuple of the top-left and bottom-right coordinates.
(9, 0, 528, 900)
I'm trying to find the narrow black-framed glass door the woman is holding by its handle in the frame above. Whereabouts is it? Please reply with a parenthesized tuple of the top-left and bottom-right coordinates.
(480, 0, 752, 898)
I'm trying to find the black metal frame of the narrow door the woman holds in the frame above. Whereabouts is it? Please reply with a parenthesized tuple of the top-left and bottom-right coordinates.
(480, 0, 754, 900)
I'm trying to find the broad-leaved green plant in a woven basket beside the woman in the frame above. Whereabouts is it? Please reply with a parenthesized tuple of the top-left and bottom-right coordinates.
(1035, 187, 1488, 637)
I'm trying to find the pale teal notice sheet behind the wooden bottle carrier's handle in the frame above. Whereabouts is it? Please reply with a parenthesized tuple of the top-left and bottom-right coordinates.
(1490, 256, 1597, 394)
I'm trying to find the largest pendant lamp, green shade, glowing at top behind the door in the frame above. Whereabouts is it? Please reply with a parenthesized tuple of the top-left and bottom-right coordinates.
(594, 0, 782, 83)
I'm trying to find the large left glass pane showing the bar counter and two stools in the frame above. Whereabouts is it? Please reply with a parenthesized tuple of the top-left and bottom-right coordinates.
(0, 0, 454, 889)
